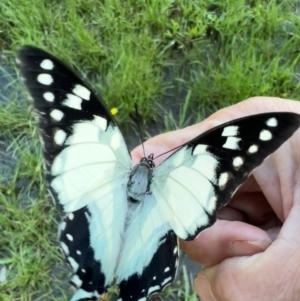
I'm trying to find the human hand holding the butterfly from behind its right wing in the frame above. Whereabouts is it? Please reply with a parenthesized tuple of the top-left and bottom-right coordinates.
(132, 97, 300, 301)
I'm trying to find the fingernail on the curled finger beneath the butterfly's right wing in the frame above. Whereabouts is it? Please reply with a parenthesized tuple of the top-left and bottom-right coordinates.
(230, 239, 271, 255)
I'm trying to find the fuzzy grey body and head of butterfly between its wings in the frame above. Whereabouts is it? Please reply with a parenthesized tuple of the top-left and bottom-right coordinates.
(127, 154, 155, 203)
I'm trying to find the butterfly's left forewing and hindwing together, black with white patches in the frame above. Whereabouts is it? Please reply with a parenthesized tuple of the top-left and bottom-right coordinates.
(18, 46, 132, 301)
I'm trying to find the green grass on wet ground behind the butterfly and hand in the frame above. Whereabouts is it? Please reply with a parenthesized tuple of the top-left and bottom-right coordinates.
(0, 0, 300, 301)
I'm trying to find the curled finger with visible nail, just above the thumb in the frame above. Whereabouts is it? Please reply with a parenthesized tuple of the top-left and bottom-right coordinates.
(180, 220, 272, 265)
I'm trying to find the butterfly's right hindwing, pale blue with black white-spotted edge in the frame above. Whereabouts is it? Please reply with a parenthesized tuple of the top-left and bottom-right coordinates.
(116, 195, 178, 301)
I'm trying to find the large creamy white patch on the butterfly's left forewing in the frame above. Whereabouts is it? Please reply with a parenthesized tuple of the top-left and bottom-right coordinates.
(50, 121, 132, 212)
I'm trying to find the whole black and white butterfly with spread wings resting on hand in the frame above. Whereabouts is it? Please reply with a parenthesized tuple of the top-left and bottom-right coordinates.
(18, 46, 300, 301)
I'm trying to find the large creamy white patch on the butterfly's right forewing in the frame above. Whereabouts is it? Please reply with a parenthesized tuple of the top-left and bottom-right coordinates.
(152, 145, 218, 239)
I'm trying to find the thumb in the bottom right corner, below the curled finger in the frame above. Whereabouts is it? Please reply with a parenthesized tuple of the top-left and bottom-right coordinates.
(195, 203, 300, 301)
